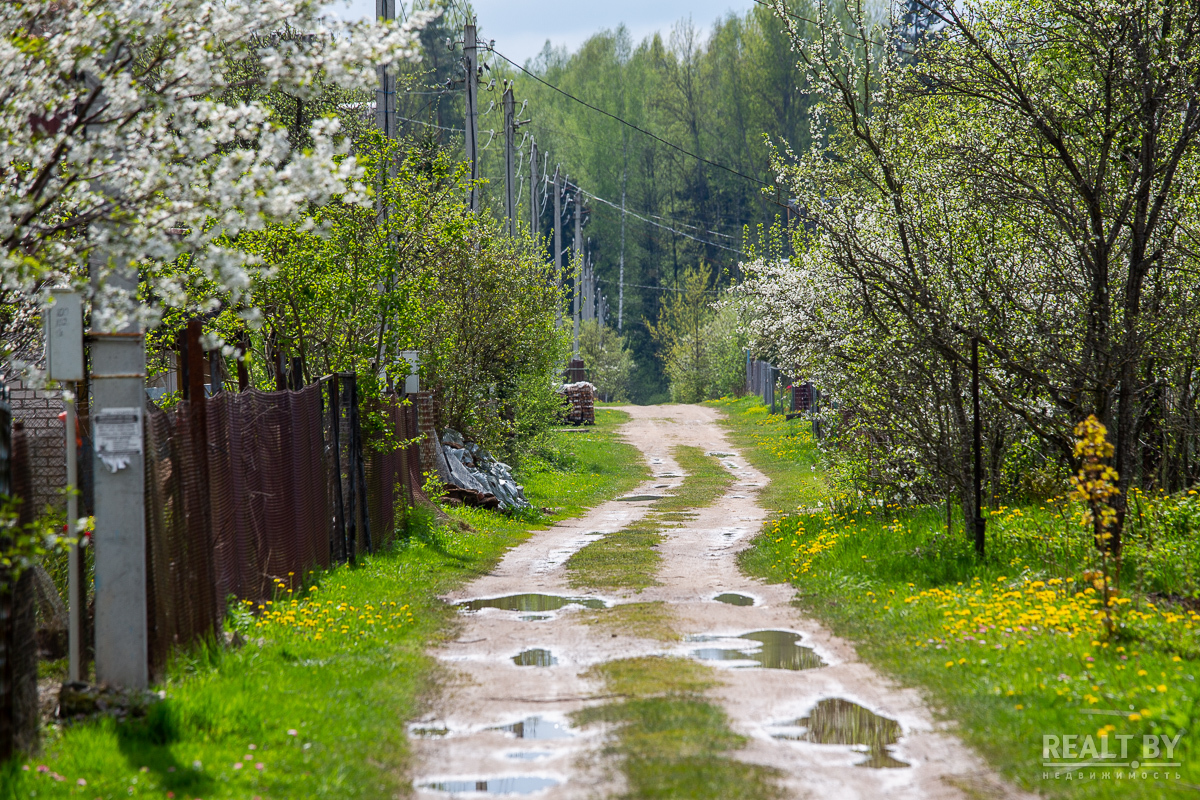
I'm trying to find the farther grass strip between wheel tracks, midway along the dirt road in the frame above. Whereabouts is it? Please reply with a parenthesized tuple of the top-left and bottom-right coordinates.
(566, 446, 733, 591)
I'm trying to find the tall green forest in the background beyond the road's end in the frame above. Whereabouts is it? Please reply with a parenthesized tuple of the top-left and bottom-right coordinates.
(388, 0, 882, 403)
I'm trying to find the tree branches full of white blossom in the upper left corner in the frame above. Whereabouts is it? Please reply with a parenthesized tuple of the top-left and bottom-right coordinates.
(0, 0, 430, 350)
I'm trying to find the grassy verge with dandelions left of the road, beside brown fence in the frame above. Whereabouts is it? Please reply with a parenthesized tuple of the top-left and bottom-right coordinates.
(11, 409, 646, 800)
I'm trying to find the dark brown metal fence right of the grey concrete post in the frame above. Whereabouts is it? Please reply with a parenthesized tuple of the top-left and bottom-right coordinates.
(146, 374, 420, 674)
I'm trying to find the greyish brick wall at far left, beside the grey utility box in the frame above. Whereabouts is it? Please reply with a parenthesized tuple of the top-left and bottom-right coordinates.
(6, 378, 67, 513)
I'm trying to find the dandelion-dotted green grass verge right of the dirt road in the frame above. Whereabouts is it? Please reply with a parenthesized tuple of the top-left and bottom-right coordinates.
(721, 401, 1200, 798)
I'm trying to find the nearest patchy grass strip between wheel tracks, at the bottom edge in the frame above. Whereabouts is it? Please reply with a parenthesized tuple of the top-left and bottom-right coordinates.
(575, 657, 782, 800)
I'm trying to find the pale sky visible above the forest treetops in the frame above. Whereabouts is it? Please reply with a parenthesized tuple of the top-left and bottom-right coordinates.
(321, 0, 754, 64)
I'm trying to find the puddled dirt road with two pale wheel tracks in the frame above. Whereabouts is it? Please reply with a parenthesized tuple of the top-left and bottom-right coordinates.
(410, 405, 1022, 800)
